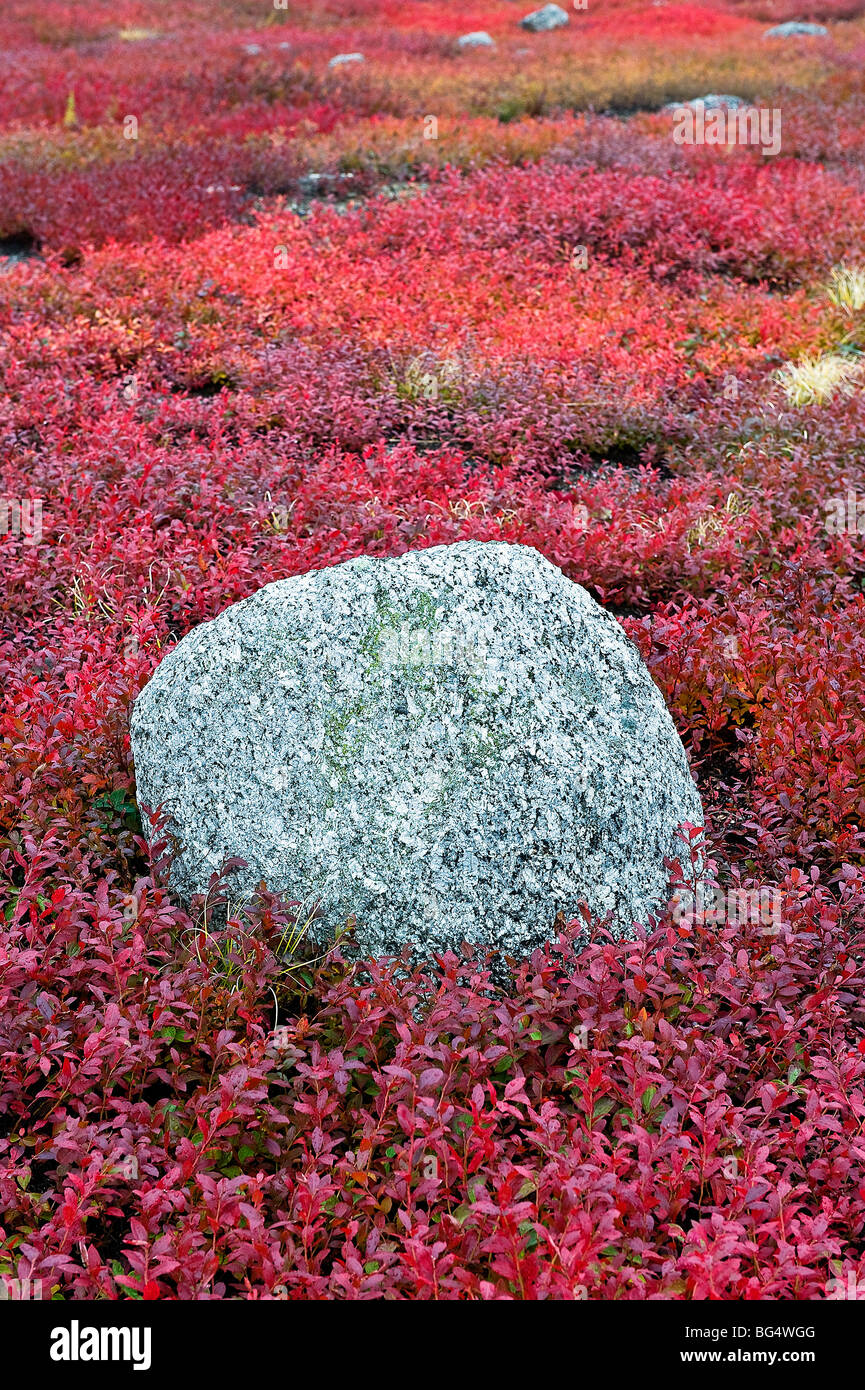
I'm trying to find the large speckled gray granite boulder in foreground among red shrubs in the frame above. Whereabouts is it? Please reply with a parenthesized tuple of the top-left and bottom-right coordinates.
(132, 541, 702, 956)
